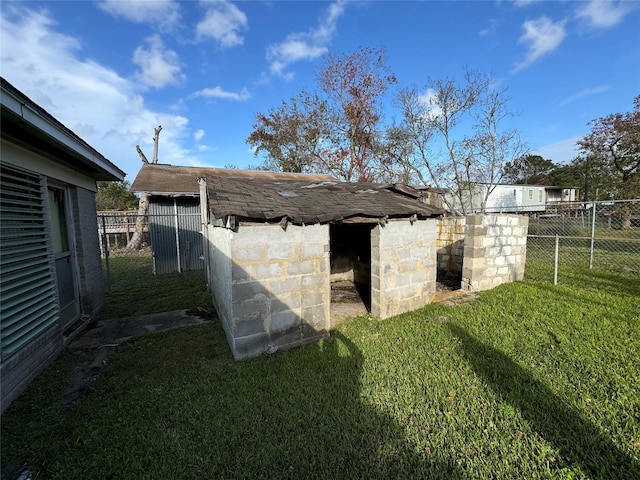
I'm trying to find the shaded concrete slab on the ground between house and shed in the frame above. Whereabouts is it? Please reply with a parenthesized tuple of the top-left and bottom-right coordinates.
(69, 310, 216, 348)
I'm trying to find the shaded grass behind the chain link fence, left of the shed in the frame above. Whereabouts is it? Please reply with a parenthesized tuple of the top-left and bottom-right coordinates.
(98, 255, 211, 319)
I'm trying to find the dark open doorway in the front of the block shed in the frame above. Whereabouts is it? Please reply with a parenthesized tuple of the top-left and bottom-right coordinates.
(329, 223, 375, 318)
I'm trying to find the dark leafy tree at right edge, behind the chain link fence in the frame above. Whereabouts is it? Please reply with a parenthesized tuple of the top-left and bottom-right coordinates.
(578, 95, 640, 228)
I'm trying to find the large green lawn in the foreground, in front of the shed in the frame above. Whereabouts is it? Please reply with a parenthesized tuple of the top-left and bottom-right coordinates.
(1, 265, 640, 480)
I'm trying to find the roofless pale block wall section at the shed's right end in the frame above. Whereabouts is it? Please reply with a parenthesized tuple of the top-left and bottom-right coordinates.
(462, 214, 529, 291)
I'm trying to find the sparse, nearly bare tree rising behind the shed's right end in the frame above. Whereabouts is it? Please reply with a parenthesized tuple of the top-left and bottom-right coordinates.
(391, 70, 528, 213)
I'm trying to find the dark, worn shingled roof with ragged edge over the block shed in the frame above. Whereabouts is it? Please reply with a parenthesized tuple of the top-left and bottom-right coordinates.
(204, 174, 445, 224)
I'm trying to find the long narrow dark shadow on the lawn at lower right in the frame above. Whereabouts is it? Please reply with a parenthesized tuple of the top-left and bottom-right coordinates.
(448, 324, 640, 480)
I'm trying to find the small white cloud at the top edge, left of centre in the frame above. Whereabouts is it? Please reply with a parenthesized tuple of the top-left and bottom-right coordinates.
(196, 0, 248, 47)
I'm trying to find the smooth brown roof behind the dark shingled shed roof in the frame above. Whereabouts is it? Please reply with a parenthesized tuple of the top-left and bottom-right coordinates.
(131, 164, 333, 196)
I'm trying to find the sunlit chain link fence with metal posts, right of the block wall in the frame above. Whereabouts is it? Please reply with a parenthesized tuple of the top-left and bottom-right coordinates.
(527, 199, 640, 278)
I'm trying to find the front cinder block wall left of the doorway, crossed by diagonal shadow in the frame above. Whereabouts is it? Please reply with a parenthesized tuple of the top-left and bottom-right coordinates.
(230, 225, 330, 359)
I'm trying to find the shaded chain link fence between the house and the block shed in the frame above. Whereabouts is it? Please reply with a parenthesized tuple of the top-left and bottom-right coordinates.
(97, 211, 210, 318)
